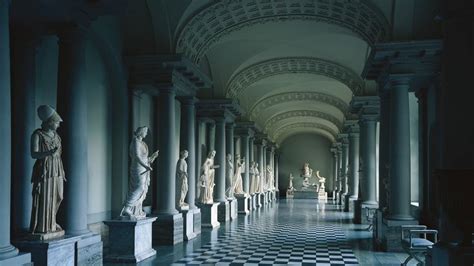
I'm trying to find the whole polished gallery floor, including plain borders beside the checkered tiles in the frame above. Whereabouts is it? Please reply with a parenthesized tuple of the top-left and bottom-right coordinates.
(106, 199, 412, 265)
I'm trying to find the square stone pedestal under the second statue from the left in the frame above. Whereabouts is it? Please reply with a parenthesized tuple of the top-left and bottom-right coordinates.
(104, 217, 156, 263)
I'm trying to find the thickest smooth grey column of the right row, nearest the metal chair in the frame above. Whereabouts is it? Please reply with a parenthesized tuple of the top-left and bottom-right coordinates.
(389, 77, 413, 220)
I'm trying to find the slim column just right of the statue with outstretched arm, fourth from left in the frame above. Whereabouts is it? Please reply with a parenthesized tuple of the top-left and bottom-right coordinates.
(214, 117, 226, 202)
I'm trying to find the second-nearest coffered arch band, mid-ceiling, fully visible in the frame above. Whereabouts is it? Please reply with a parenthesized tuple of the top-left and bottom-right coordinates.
(226, 57, 364, 98)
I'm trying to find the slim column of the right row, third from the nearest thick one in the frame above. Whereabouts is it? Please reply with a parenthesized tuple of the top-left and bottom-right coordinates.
(344, 125, 360, 212)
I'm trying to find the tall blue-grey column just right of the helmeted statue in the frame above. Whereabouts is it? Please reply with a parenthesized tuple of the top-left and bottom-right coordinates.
(57, 27, 89, 235)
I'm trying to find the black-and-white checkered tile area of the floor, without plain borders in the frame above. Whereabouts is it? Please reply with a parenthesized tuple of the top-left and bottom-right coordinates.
(173, 203, 358, 265)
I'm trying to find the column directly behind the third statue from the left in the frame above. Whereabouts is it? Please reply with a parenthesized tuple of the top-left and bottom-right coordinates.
(180, 97, 196, 209)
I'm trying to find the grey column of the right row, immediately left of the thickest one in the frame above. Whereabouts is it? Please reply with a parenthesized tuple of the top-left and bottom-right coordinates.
(359, 117, 377, 205)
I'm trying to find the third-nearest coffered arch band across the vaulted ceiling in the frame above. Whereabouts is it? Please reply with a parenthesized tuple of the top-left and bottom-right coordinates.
(249, 92, 349, 120)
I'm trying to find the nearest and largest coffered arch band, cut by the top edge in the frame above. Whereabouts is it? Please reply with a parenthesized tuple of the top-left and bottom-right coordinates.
(176, 0, 389, 63)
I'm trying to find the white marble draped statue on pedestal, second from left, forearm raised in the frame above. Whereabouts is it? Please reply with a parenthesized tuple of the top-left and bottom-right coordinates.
(120, 126, 159, 219)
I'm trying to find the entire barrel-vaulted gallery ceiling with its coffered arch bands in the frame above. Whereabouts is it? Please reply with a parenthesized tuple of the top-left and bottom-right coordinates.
(121, 0, 389, 143)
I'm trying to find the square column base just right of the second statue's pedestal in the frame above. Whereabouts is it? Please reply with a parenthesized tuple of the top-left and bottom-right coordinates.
(152, 213, 184, 245)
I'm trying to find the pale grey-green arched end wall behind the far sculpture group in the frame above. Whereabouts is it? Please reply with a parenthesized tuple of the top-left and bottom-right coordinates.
(278, 133, 334, 193)
